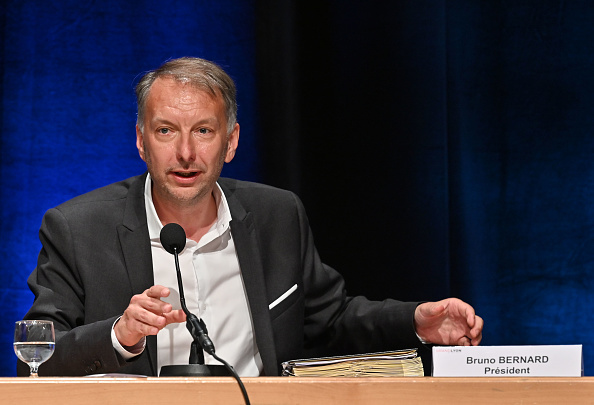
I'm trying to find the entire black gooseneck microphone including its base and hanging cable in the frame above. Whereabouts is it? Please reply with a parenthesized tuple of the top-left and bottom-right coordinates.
(159, 223, 250, 405)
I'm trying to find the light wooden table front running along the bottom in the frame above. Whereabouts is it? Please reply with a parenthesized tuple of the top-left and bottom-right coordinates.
(0, 377, 594, 405)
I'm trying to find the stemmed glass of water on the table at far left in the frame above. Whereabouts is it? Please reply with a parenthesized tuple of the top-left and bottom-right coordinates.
(14, 321, 56, 377)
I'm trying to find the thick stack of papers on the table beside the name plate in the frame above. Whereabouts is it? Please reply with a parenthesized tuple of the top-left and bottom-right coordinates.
(282, 349, 424, 377)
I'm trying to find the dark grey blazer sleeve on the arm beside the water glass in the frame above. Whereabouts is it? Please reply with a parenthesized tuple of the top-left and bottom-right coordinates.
(17, 208, 126, 376)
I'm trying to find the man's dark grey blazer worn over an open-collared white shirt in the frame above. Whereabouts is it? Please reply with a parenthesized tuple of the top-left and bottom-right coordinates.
(18, 174, 419, 376)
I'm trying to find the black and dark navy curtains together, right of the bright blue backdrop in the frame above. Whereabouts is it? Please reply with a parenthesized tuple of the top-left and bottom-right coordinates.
(256, 0, 594, 374)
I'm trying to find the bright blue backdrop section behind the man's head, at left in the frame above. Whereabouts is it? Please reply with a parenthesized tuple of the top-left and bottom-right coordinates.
(0, 0, 258, 375)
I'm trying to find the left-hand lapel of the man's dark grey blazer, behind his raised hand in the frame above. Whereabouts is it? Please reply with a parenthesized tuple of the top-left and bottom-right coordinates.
(118, 174, 157, 375)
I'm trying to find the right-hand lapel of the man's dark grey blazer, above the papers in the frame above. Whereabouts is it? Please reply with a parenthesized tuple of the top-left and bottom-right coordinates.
(221, 186, 278, 376)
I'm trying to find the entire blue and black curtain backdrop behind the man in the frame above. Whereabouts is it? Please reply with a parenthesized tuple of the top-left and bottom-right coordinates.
(0, 0, 594, 376)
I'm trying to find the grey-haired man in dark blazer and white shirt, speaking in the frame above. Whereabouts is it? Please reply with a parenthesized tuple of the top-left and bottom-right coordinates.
(19, 58, 483, 376)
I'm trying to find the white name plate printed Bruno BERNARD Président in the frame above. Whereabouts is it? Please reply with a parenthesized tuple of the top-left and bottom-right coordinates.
(433, 345, 584, 377)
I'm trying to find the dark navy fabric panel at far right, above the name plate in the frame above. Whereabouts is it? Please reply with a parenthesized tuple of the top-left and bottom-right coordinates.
(447, 1, 594, 356)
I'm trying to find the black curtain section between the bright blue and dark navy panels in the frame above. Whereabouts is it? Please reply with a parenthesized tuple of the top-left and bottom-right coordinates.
(257, 1, 450, 300)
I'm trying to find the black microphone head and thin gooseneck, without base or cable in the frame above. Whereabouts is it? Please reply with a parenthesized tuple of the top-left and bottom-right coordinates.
(160, 223, 215, 355)
